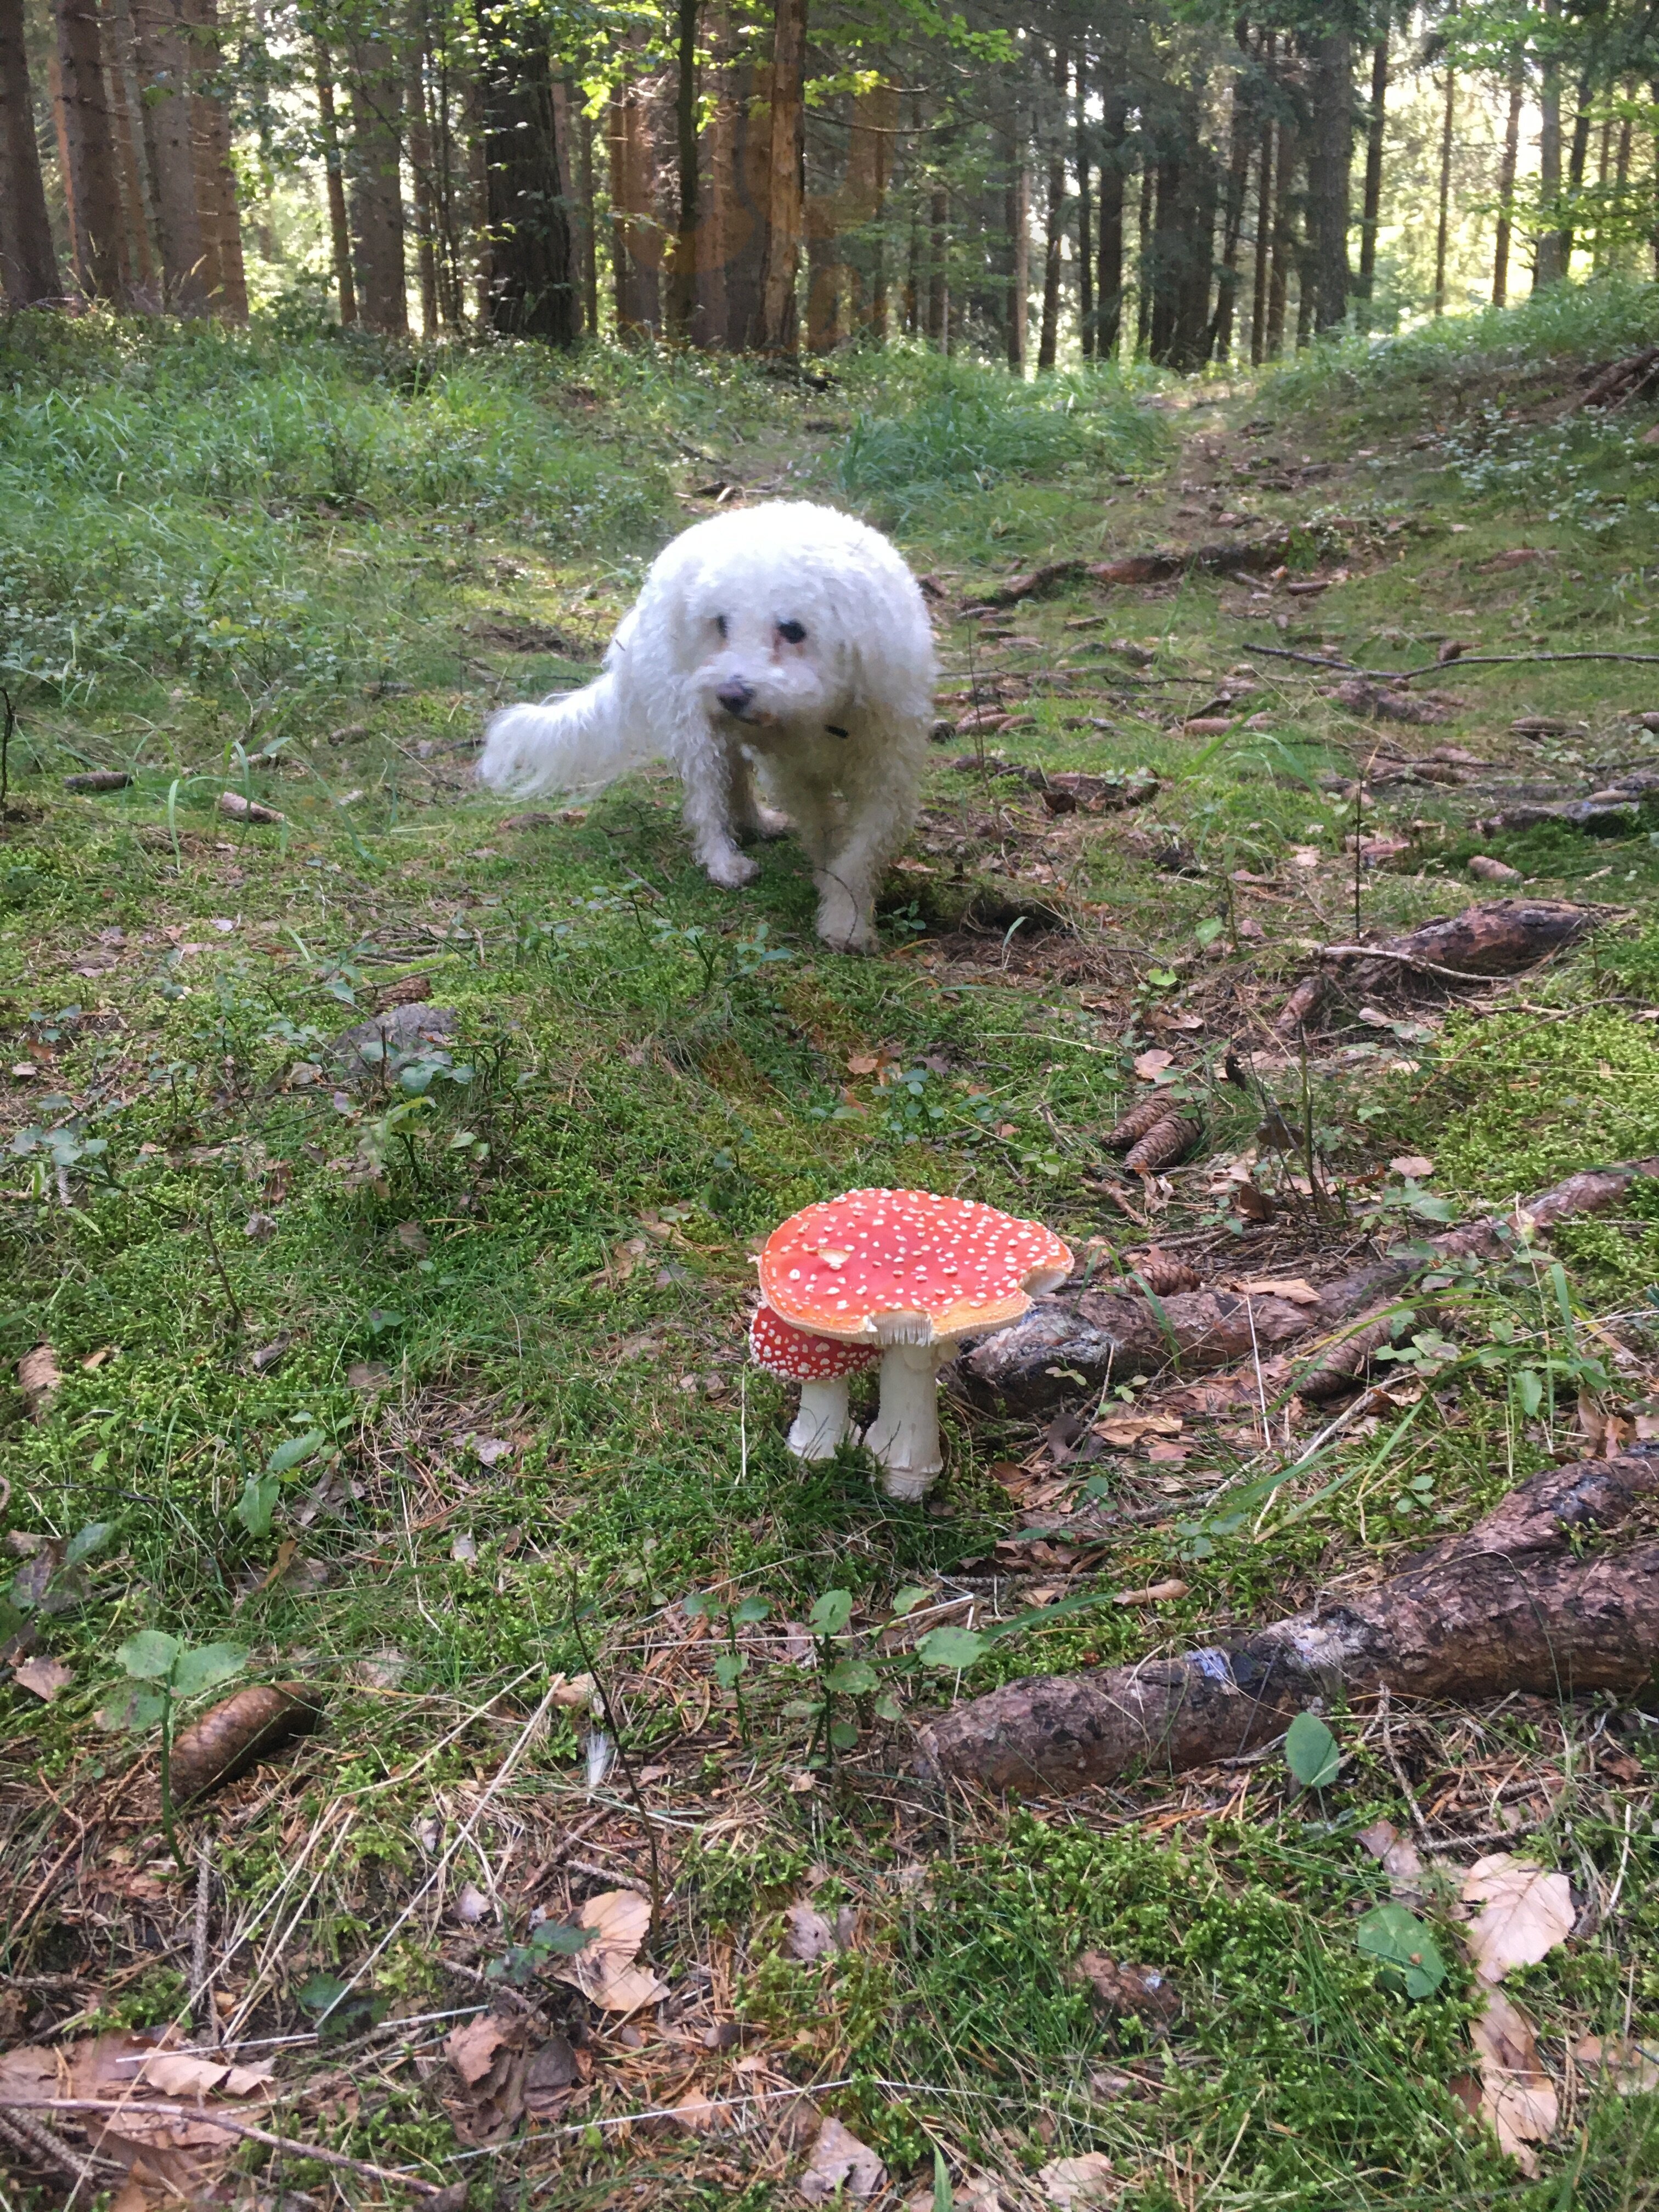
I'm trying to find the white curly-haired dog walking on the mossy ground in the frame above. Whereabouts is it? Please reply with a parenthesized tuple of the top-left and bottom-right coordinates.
(478, 500, 936, 953)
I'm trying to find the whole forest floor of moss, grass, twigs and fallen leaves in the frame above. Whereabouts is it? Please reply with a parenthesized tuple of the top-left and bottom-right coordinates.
(0, 292, 1659, 2212)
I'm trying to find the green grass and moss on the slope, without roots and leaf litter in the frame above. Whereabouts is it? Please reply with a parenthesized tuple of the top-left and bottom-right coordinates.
(0, 294, 1659, 2208)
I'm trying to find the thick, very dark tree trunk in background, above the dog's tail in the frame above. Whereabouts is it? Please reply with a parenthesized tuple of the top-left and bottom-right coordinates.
(478, 0, 577, 345)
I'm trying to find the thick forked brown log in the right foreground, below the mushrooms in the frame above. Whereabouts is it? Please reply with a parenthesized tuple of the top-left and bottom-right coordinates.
(920, 1447, 1659, 1790)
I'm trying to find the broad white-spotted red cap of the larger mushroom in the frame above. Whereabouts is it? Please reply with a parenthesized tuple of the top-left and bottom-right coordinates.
(761, 1190, 1070, 1345)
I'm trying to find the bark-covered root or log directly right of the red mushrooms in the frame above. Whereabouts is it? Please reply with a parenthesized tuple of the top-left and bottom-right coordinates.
(960, 1157, 1659, 1413)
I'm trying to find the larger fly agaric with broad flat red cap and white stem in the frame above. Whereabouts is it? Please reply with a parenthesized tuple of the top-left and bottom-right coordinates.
(761, 1190, 1070, 1500)
